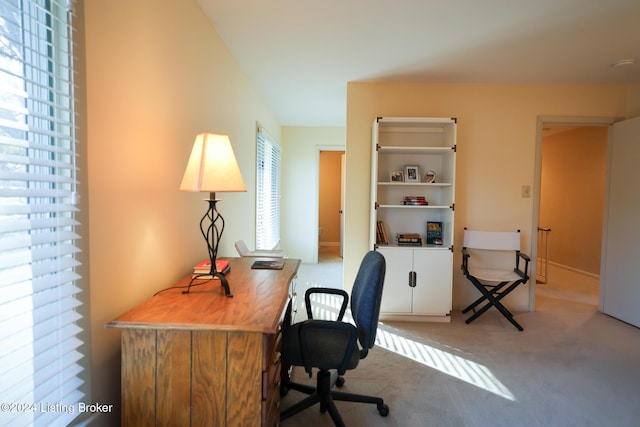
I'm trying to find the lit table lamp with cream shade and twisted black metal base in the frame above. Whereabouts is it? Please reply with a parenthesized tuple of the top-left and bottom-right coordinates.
(180, 133, 247, 297)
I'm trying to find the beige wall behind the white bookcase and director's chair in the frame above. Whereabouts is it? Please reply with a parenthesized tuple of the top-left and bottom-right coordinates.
(344, 83, 637, 309)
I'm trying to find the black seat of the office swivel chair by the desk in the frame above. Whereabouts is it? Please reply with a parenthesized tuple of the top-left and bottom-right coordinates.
(299, 320, 359, 376)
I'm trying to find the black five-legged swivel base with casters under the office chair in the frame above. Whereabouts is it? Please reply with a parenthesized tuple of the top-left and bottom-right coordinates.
(280, 370, 389, 427)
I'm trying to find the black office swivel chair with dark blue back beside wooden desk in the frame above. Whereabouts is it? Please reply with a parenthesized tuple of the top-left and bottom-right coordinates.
(280, 251, 389, 426)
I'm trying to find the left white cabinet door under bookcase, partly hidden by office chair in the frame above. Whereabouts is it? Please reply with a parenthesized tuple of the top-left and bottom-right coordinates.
(378, 248, 413, 314)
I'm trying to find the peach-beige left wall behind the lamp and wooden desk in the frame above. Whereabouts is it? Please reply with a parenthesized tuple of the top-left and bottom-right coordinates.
(85, 0, 280, 425)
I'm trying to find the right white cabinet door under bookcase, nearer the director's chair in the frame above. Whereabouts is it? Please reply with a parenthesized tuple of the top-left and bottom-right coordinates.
(413, 249, 453, 316)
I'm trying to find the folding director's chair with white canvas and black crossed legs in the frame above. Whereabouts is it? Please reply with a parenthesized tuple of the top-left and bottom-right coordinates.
(462, 228, 531, 331)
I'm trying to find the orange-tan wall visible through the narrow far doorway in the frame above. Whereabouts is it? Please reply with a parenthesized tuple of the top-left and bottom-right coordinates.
(318, 151, 344, 246)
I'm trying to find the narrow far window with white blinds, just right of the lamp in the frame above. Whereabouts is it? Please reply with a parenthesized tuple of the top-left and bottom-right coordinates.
(256, 126, 280, 250)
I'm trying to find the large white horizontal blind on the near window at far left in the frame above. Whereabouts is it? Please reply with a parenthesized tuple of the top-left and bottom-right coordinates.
(0, 0, 83, 426)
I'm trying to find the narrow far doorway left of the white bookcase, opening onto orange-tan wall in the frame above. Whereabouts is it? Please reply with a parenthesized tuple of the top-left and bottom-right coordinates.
(318, 148, 345, 262)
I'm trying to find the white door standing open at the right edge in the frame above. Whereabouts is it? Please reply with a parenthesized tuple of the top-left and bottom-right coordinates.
(600, 117, 640, 327)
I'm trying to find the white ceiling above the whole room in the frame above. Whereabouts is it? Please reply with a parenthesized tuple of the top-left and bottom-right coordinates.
(198, 0, 640, 126)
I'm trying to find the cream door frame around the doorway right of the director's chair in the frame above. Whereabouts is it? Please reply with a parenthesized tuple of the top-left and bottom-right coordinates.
(529, 116, 622, 311)
